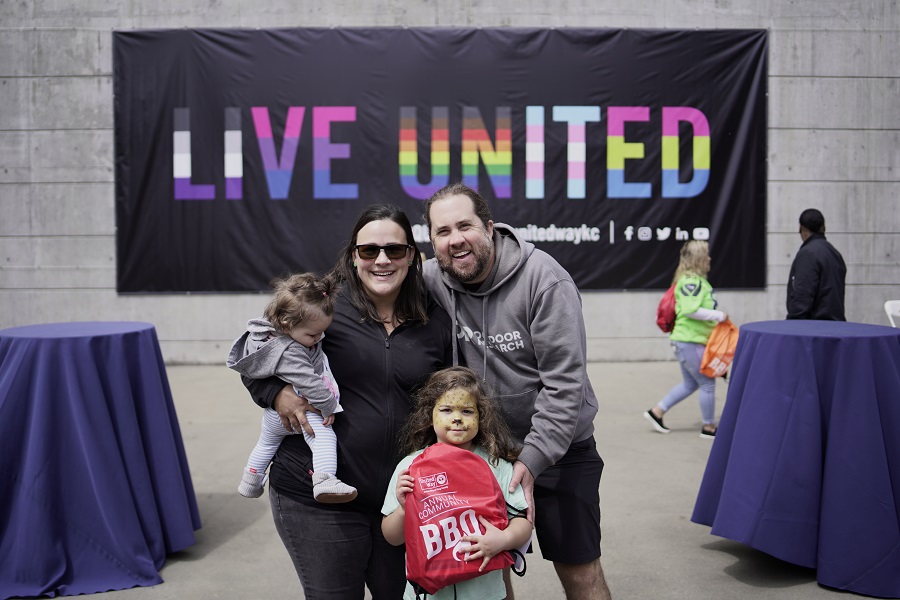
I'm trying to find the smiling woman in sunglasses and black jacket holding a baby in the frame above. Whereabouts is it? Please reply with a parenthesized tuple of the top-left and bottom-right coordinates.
(244, 204, 452, 600)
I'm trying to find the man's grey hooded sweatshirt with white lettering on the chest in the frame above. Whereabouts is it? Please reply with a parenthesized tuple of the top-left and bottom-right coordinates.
(425, 223, 597, 477)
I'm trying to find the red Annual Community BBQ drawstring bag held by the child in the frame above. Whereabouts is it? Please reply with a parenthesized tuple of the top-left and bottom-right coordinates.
(403, 443, 513, 596)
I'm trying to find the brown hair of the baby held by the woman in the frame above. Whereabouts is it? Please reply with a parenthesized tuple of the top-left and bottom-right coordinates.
(263, 273, 338, 333)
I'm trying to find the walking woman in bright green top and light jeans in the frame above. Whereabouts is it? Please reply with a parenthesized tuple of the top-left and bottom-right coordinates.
(644, 240, 728, 439)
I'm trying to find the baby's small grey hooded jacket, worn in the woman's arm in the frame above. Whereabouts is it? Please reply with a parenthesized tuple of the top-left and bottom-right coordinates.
(225, 319, 343, 417)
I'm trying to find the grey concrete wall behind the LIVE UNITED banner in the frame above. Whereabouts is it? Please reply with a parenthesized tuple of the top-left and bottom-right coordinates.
(0, 0, 900, 364)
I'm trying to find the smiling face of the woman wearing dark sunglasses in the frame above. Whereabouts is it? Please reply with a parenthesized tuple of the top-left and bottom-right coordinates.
(353, 219, 413, 306)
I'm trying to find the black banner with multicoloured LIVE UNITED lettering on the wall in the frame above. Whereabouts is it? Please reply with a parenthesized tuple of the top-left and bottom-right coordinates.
(113, 28, 767, 293)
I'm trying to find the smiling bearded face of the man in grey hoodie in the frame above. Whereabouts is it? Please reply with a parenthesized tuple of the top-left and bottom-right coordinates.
(429, 194, 494, 283)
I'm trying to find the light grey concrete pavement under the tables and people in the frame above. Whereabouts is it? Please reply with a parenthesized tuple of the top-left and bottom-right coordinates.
(65, 362, 843, 600)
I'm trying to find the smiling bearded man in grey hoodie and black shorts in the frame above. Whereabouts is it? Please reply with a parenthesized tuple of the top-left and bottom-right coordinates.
(424, 183, 610, 600)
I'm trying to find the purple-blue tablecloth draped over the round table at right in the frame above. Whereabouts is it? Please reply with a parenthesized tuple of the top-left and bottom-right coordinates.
(691, 321, 900, 598)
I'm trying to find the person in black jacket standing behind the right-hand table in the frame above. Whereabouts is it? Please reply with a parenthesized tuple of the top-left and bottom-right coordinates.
(787, 208, 847, 321)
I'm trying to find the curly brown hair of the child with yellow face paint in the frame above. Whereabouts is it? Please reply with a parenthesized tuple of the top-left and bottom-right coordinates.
(400, 367, 520, 465)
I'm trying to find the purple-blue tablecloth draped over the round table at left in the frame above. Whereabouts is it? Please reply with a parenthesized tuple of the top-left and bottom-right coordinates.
(0, 322, 200, 598)
